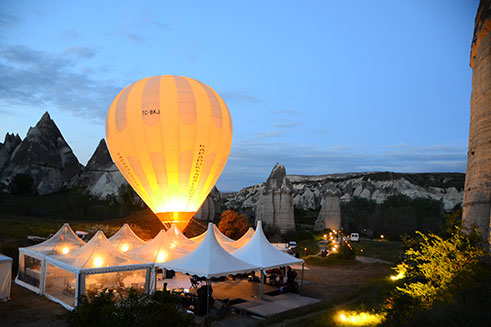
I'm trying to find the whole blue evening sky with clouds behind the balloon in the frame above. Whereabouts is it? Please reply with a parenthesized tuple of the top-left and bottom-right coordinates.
(0, 0, 478, 191)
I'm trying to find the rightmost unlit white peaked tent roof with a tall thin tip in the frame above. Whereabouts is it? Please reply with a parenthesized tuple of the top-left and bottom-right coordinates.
(231, 221, 303, 269)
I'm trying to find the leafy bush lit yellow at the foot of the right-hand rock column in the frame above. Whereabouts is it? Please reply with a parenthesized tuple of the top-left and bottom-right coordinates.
(386, 228, 488, 326)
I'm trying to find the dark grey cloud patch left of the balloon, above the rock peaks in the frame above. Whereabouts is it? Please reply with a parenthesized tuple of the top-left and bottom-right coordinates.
(0, 46, 121, 121)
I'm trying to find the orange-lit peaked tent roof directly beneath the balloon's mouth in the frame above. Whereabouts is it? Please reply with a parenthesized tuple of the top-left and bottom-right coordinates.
(126, 230, 189, 262)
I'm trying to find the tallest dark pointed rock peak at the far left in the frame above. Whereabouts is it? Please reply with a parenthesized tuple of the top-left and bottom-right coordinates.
(0, 112, 82, 195)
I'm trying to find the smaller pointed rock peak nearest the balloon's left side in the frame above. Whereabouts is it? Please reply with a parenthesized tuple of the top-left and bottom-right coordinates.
(71, 139, 127, 198)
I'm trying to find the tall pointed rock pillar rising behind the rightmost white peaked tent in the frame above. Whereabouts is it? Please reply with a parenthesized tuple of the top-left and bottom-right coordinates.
(256, 163, 295, 232)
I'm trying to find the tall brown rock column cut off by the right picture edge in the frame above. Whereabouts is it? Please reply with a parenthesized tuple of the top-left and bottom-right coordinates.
(462, 0, 491, 248)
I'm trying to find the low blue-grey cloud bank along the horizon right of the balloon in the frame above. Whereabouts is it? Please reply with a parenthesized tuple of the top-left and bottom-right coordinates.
(218, 141, 466, 191)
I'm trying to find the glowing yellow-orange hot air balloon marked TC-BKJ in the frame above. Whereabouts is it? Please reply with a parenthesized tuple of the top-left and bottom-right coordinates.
(106, 75, 232, 230)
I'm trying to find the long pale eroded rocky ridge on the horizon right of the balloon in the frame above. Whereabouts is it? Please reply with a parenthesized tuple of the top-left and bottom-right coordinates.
(222, 168, 465, 212)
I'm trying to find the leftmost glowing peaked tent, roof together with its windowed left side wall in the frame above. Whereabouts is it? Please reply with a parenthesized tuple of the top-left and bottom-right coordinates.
(15, 223, 85, 293)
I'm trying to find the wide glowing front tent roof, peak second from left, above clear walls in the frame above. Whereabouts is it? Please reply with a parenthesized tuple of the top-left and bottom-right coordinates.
(52, 231, 150, 270)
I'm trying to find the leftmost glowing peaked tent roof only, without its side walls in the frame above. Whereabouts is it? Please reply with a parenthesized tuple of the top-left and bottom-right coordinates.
(24, 223, 85, 255)
